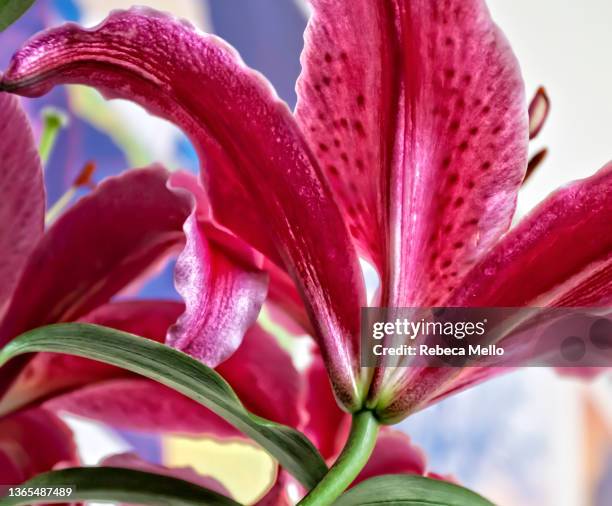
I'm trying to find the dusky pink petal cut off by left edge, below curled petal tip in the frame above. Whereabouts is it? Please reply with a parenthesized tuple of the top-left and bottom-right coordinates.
(0, 93, 45, 318)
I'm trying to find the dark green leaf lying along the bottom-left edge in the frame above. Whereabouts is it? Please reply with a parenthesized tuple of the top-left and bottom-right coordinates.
(0, 467, 239, 506)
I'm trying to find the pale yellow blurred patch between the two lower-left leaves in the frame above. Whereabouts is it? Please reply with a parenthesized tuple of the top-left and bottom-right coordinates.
(162, 437, 276, 504)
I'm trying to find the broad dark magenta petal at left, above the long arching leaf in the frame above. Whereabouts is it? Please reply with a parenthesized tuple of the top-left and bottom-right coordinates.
(0, 168, 190, 343)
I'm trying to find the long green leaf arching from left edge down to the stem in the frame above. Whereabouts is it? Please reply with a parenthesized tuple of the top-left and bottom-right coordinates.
(0, 323, 327, 489)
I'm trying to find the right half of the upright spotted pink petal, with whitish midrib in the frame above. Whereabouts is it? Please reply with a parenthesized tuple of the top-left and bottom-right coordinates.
(390, 0, 528, 306)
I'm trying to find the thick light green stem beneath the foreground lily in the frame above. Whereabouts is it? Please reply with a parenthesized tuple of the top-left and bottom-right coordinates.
(298, 411, 379, 506)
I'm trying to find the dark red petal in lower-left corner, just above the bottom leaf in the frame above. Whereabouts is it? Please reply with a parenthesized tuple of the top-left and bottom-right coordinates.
(0, 408, 79, 485)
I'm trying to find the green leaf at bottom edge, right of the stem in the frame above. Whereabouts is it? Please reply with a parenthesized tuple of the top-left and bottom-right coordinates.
(334, 474, 493, 506)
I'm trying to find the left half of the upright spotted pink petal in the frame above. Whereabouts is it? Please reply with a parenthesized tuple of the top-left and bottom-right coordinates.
(296, 0, 399, 270)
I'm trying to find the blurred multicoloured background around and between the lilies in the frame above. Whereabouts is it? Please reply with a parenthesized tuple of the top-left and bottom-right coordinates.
(0, 0, 612, 506)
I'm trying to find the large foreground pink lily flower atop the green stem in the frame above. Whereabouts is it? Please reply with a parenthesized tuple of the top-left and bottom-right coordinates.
(2, 0, 612, 423)
